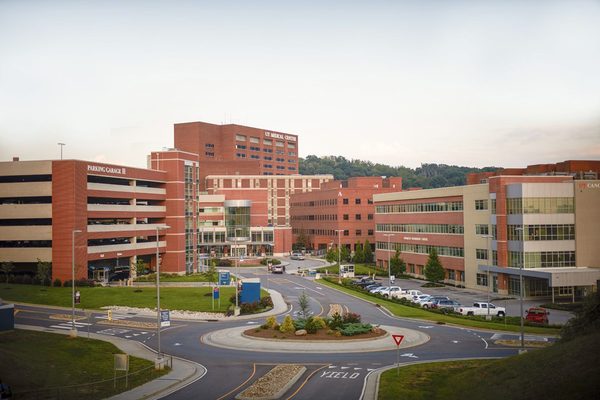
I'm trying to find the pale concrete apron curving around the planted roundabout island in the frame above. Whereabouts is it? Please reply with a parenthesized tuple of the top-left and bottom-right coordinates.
(200, 325, 430, 353)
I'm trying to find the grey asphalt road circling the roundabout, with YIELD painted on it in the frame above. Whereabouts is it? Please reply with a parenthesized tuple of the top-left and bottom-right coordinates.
(16, 260, 556, 400)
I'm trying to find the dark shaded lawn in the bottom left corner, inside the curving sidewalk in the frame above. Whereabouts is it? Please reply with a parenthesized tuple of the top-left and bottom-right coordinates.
(0, 330, 168, 400)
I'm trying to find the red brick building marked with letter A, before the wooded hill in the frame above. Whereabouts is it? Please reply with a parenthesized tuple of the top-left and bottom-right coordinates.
(290, 177, 402, 251)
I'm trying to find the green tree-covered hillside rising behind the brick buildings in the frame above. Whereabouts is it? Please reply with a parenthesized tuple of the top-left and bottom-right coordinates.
(300, 155, 498, 189)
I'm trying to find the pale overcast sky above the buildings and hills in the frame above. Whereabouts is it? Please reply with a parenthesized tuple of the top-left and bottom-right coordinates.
(0, 0, 600, 168)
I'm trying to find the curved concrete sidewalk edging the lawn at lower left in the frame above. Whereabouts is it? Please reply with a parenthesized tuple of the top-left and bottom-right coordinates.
(15, 325, 206, 400)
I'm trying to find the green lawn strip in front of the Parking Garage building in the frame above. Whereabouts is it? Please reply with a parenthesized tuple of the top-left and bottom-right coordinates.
(0, 284, 235, 312)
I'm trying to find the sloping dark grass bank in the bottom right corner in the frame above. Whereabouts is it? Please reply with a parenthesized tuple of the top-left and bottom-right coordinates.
(378, 332, 600, 400)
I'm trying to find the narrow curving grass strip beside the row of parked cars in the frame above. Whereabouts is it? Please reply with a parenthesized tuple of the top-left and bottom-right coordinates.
(319, 279, 560, 335)
